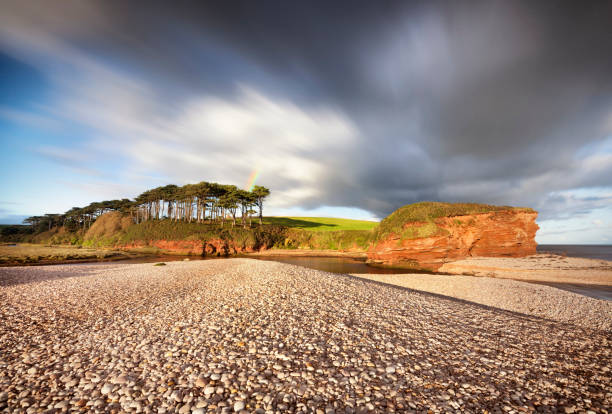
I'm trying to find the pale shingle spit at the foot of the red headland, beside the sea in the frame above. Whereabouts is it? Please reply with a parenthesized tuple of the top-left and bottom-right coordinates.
(439, 254, 612, 286)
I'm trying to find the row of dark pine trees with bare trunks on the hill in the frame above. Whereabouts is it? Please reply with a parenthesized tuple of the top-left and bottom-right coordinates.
(23, 181, 270, 231)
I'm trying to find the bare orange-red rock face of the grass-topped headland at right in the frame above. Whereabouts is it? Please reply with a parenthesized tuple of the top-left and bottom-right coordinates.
(368, 210, 539, 270)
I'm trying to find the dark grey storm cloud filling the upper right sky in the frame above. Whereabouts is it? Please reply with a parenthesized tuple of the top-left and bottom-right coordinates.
(2, 1, 612, 217)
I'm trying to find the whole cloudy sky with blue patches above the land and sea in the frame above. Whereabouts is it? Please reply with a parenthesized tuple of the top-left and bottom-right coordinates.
(0, 0, 612, 244)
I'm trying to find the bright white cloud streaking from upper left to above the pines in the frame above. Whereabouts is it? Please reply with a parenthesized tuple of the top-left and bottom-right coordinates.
(0, 10, 358, 210)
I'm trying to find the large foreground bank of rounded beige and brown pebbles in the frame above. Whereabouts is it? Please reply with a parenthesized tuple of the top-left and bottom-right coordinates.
(0, 259, 612, 414)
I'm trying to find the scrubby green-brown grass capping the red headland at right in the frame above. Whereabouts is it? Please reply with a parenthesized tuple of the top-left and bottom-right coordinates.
(375, 201, 533, 240)
